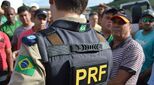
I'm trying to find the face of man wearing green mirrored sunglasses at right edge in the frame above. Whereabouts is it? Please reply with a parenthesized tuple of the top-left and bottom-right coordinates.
(142, 16, 154, 31)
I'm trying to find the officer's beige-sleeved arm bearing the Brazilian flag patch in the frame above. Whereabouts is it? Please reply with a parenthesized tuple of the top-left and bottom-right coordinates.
(8, 44, 45, 85)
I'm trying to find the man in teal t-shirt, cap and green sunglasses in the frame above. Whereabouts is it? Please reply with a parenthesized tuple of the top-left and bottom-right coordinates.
(134, 10, 154, 85)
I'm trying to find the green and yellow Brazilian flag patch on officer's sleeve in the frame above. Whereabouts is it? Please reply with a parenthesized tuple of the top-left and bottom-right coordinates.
(15, 55, 35, 76)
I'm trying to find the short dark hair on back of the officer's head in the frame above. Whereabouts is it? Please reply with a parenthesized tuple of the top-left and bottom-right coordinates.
(55, 0, 88, 14)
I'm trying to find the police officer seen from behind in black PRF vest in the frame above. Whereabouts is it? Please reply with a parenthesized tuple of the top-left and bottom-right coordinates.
(9, 0, 112, 85)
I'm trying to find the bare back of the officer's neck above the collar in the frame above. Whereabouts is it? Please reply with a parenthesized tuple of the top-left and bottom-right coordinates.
(53, 11, 80, 21)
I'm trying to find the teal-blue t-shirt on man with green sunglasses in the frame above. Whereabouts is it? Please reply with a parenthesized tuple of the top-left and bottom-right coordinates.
(134, 30, 154, 72)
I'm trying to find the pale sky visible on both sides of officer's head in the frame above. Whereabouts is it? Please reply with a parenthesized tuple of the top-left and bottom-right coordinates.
(23, 0, 113, 7)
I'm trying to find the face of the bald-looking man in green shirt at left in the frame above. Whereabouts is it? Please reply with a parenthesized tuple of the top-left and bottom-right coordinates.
(5, 9, 16, 22)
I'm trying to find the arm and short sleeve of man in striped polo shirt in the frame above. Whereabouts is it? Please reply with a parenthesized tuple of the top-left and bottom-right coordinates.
(108, 46, 144, 85)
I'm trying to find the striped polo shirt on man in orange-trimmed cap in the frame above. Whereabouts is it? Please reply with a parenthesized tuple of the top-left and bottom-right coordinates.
(110, 37, 144, 85)
